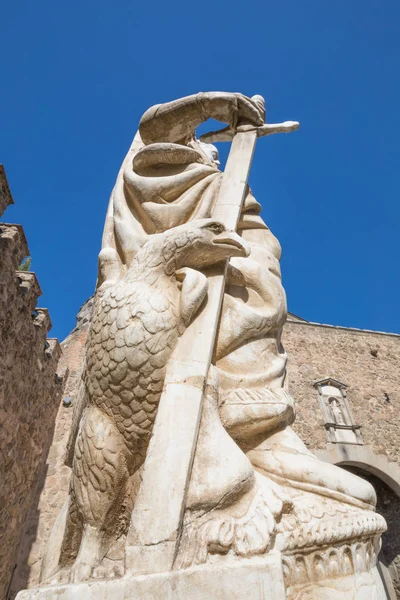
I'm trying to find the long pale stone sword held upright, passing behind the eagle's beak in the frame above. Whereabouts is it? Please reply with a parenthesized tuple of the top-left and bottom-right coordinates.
(126, 96, 299, 574)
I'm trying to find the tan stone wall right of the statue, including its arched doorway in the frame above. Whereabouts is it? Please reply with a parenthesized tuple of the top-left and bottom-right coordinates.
(283, 320, 400, 600)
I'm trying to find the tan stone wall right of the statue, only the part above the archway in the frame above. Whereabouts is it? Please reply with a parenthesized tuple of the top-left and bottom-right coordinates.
(283, 321, 400, 463)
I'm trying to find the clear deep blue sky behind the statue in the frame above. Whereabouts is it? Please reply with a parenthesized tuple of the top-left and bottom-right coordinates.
(0, 0, 400, 339)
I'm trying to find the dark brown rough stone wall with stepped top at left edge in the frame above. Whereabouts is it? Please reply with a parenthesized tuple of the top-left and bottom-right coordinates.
(0, 167, 62, 598)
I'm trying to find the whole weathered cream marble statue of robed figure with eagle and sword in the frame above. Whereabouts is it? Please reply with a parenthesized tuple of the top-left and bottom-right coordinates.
(21, 92, 386, 600)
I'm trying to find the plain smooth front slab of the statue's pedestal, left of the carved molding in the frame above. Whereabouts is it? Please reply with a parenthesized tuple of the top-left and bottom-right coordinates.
(17, 552, 286, 600)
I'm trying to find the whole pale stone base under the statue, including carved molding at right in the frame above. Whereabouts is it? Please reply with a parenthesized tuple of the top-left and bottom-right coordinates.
(17, 539, 386, 600)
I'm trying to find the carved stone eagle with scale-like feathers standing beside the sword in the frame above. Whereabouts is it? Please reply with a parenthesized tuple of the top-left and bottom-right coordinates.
(42, 219, 252, 580)
